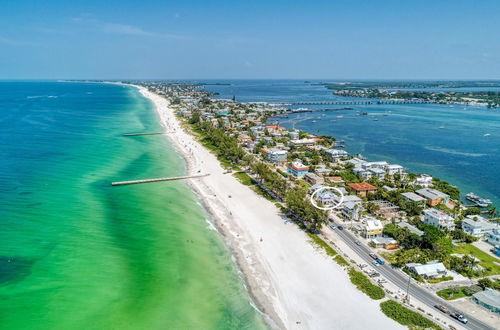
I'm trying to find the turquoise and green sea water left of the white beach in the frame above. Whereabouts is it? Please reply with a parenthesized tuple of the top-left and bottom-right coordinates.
(0, 82, 266, 330)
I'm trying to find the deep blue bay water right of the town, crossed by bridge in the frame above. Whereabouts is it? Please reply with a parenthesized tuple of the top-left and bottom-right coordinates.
(205, 80, 500, 206)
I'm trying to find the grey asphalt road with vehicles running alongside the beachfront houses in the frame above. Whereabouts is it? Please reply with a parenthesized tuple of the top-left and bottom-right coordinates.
(324, 224, 494, 330)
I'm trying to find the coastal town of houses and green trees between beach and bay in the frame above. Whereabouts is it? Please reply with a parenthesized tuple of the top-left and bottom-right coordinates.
(133, 81, 500, 328)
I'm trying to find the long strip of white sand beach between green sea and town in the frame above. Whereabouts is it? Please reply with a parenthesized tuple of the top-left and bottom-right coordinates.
(138, 87, 403, 329)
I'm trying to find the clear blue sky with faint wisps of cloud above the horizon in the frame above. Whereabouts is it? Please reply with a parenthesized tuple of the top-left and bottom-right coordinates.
(0, 0, 500, 79)
